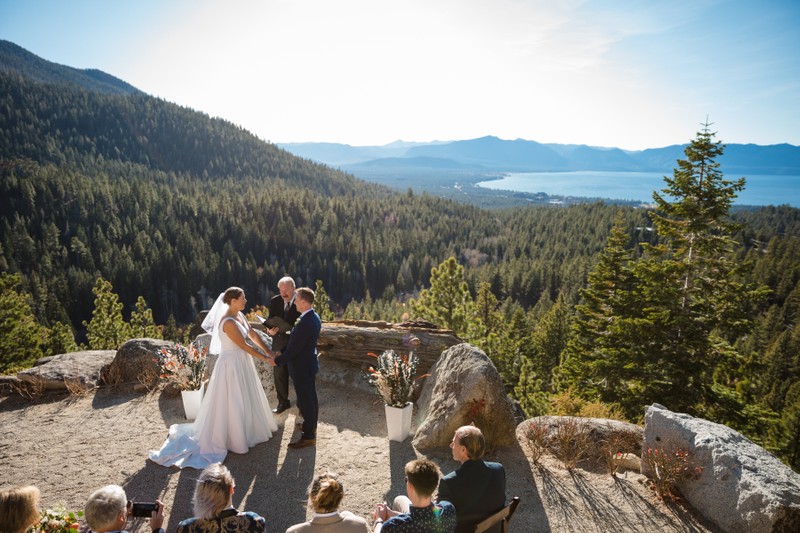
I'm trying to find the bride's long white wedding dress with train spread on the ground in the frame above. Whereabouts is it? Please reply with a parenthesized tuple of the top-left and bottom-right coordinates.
(150, 313, 278, 469)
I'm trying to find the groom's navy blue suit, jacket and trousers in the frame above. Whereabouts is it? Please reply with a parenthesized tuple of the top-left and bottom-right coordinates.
(275, 309, 322, 440)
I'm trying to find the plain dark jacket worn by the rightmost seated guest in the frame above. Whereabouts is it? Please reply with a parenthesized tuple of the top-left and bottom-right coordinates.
(439, 459, 506, 533)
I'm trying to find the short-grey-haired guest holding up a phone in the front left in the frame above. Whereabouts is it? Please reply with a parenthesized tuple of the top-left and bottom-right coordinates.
(83, 485, 164, 533)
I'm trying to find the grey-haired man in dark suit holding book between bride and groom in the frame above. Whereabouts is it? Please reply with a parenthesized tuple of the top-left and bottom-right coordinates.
(264, 276, 300, 414)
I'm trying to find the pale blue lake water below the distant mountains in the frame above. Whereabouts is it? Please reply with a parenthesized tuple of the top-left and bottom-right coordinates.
(477, 171, 800, 207)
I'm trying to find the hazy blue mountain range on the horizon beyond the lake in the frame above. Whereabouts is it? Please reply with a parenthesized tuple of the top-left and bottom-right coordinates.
(278, 136, 800, 177)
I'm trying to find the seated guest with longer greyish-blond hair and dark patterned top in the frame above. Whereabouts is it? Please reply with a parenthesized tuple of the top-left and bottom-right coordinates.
(178, 463, 267, 533)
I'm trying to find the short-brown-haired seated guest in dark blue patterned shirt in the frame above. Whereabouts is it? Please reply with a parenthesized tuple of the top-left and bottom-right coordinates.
(372, 458, 456, 533)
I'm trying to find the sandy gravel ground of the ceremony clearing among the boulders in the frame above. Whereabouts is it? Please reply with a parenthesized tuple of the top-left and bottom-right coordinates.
(0, 358, 716, 533)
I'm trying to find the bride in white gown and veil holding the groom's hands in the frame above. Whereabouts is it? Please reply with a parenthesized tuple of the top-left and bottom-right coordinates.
(150, 287, 278, 469)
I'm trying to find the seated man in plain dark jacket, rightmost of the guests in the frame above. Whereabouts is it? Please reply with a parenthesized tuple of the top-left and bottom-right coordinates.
(438, 426, 506, 533)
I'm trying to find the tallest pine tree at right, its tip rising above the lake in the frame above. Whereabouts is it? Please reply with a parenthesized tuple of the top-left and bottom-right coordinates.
(634, 124, 763, 415)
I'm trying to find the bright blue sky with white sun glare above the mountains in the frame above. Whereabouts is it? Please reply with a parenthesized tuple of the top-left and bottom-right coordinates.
(0, 0, 800, 150)
